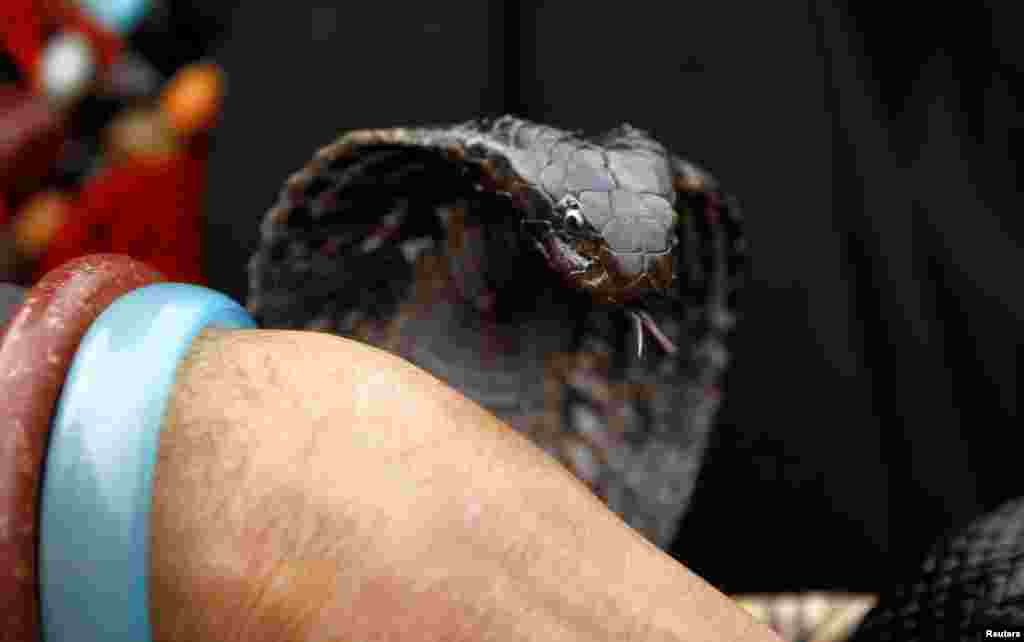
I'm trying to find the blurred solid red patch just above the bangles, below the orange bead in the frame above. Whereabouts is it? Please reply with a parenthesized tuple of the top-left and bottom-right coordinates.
(36, 136, 207, 285)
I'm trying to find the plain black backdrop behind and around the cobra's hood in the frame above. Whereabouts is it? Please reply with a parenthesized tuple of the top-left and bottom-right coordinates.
(195, 0, 1024, 592)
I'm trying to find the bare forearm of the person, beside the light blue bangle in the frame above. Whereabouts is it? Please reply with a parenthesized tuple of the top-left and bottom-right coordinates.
(151, 330, 778, 642)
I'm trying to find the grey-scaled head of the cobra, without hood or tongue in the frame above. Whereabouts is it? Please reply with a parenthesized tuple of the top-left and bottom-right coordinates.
(523, 125, 679, 311)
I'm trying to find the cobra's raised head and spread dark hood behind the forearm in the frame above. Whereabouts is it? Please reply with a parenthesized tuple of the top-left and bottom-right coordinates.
(247, 116, 748, 549)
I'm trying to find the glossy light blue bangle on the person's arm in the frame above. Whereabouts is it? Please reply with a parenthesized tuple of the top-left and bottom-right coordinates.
(39, 284, 255, 642)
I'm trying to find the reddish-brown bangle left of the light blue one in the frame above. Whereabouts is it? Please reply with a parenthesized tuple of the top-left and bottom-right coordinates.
(0, 254, 166, 642)
